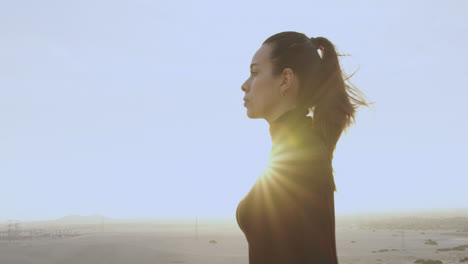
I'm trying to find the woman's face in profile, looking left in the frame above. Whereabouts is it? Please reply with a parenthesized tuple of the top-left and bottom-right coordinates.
(241, 44, 281, 118)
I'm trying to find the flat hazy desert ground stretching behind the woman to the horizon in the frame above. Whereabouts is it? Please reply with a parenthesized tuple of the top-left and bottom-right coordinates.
(0, 214, 468, 264)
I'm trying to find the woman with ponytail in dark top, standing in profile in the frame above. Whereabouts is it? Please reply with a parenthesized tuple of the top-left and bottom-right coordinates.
(236, 32, 368, 264)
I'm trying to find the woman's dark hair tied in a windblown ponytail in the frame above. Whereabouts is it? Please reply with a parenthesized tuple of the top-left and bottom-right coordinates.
(263, 31, 371, 191)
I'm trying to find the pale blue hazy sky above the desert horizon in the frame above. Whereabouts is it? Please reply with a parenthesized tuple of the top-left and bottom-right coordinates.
(0, 0, 468, 221)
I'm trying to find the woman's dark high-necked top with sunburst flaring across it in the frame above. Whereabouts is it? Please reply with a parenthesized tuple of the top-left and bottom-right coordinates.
(236, 108, 338, 264)
